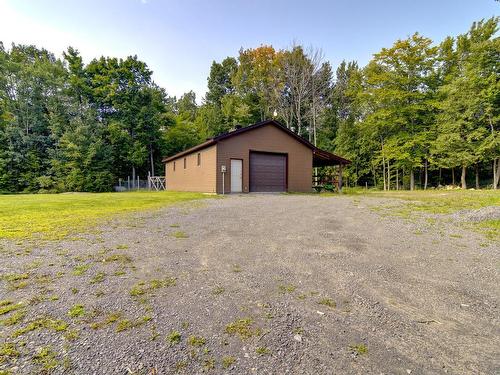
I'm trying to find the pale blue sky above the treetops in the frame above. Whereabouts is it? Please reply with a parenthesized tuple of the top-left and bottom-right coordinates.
(0, 0, 500, 99)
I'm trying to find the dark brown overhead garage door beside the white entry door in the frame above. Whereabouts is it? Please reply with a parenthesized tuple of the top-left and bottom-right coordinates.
(250, 152, 286, 191)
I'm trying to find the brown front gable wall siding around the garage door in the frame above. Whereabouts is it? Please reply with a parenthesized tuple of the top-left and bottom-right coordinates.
(217, 124, 312, 193)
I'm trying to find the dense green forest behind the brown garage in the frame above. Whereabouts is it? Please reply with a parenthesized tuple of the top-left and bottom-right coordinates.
(0, 17, 500, 192)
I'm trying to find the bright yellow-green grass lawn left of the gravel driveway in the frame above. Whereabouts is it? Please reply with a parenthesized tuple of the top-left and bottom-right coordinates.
(0, 191, 211, 239)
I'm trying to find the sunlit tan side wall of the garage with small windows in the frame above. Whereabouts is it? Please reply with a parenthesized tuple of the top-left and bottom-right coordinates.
(165, 145, 217, 193)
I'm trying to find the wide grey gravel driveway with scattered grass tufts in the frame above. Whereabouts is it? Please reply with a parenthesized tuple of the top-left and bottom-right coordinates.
(0, 195, 500, 374)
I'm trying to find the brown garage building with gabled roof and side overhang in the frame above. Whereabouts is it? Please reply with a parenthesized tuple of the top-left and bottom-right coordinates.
(163, 120, 350, 194)
